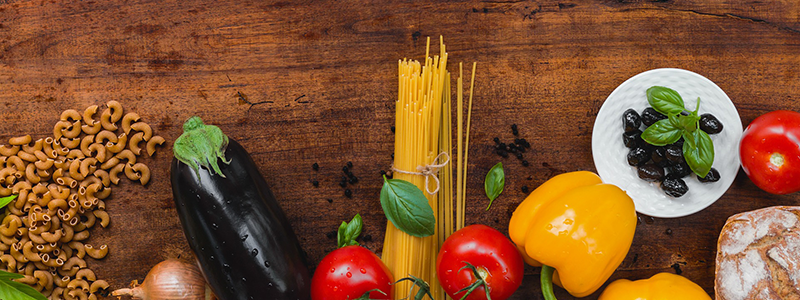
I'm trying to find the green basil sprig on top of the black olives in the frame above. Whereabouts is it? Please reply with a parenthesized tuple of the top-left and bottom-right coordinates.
(642, 86, 714, 177)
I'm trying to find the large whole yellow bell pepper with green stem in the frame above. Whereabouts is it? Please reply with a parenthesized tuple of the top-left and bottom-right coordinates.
(509, 171, 636, 299)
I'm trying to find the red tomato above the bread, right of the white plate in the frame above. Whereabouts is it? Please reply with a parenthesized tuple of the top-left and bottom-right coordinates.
(739, 110, 800, 194)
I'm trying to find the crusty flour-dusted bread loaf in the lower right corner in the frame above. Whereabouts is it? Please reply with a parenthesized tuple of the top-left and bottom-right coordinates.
(714, 206, 800, 300)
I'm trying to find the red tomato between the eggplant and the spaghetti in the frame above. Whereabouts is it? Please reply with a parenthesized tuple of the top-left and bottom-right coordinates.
(311, 246, 394, 300)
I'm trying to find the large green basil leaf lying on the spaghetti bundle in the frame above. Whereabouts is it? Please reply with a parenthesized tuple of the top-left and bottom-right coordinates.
(381, 176, 436, 237)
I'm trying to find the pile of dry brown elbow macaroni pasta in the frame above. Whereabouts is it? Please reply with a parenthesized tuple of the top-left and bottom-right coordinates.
(0, 101, 165, 300)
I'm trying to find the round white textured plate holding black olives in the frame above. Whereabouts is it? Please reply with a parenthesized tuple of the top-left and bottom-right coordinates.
(592, 69, 742, 218)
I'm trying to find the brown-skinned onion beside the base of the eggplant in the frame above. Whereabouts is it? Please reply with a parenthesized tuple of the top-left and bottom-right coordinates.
(111, 259, 216, 300)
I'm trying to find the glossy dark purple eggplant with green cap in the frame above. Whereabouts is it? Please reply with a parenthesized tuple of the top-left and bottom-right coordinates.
(170, 117, 311, 300)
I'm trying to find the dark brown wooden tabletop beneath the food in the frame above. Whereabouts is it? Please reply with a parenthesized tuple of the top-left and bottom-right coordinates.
(0, 0, 800, 299)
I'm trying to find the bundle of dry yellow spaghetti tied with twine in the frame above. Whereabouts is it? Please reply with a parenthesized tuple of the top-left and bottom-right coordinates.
(382, 39, 474, 299)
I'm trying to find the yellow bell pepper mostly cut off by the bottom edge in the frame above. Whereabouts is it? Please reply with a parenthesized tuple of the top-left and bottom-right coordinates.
(599, 273, 711, 300)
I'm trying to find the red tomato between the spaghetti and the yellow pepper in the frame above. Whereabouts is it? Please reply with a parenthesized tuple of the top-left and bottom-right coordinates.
(436, 225, 524, 300)
